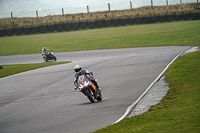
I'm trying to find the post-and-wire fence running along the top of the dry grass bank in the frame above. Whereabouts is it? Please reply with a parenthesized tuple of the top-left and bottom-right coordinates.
(0, 0, 199, 18)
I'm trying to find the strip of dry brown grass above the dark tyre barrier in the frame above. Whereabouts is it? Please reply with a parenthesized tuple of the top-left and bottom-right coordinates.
(0, 3, 200, 29)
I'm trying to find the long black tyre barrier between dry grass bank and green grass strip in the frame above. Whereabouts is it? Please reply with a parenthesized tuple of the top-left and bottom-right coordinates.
(0, 13, 200, 37)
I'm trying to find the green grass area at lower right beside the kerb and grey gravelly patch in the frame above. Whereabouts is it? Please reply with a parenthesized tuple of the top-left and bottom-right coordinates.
(95, 51, 200, 133)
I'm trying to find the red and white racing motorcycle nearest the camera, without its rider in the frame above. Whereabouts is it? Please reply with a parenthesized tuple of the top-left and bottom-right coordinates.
(77, 74, 102, 103)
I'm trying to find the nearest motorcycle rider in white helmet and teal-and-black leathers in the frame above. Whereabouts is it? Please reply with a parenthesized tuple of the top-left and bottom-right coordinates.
(74, 65, 101, 91)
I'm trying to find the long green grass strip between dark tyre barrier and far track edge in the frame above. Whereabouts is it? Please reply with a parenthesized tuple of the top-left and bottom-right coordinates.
(0, 20, 200, 56)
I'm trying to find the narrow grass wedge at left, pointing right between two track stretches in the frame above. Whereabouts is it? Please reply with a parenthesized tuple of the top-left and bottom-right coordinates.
(0, 61, 69, 78)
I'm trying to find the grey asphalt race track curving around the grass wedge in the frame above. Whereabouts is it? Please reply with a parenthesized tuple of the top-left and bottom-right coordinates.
(0, 46, 190, 133)
